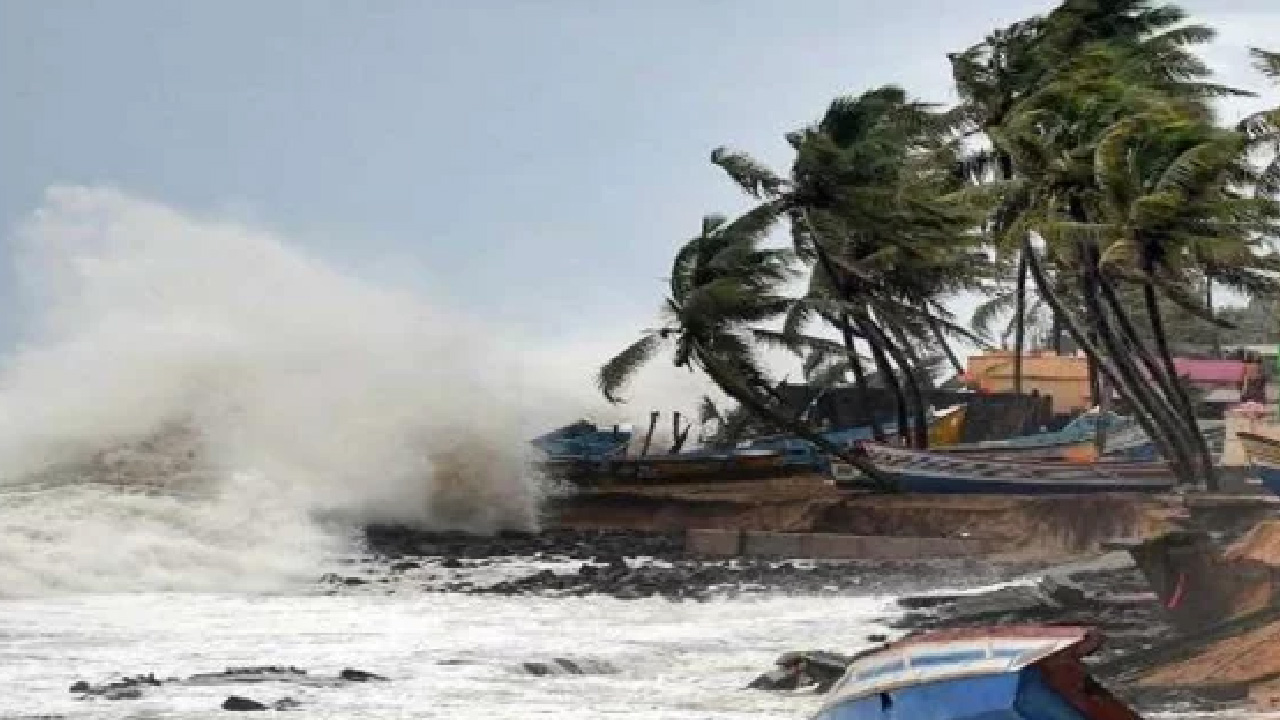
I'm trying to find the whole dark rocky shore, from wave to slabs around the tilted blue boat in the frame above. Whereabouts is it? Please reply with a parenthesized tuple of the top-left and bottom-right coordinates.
(355, 527, 1247, 712)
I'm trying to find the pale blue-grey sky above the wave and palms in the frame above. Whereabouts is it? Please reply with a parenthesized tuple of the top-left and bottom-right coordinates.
(0, 0, 1280, 409)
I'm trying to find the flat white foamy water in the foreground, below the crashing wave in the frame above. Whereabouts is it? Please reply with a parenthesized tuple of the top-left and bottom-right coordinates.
(0, 584, 887, 720)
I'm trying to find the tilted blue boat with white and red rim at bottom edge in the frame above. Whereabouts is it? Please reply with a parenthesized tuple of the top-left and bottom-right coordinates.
(814, 626, 1142, 720)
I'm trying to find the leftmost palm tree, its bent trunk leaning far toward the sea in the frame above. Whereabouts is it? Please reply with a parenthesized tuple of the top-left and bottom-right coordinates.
(596, 205, 888, 489)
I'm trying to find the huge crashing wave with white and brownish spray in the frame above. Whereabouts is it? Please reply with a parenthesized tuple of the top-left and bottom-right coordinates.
(0, 188, 577, 594)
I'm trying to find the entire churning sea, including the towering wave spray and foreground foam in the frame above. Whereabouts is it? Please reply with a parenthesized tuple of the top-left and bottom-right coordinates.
(0, 187, 887, 720)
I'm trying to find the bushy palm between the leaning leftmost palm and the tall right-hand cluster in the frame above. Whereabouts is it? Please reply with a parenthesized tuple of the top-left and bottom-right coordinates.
(712, 86, 973, 447)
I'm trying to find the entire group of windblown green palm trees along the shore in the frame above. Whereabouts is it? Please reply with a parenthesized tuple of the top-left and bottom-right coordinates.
(598, 0, 1280, 479)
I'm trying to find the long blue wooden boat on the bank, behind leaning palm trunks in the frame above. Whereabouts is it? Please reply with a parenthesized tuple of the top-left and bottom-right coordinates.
(832, 443, 1175, 495)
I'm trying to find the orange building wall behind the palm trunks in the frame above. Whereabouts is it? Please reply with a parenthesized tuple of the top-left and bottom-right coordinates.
(965, 350, 1093, 413)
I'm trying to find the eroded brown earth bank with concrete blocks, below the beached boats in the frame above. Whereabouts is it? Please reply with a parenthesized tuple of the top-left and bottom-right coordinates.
(548, 478, 1187, 561)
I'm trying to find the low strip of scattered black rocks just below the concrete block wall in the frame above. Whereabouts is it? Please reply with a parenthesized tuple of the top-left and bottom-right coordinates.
(348, 527, 1037, 601)
